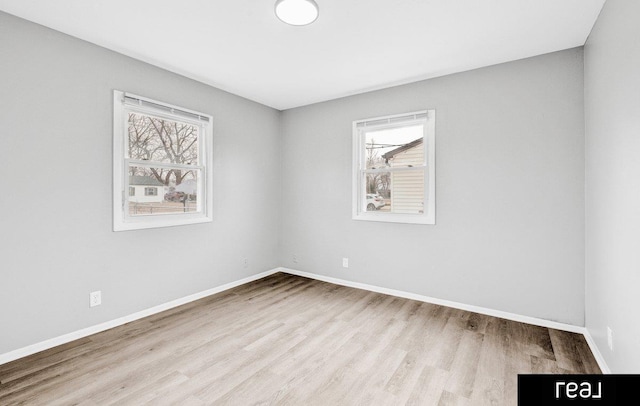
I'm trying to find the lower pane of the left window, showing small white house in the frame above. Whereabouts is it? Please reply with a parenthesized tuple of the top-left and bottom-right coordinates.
(128, 166, 199, 216)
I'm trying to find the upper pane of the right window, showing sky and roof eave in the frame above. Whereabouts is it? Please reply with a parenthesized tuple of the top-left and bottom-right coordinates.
(365, 124, 424, 169)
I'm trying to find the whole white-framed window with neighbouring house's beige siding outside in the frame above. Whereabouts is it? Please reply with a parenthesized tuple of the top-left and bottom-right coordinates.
(353, 110, 435, 224)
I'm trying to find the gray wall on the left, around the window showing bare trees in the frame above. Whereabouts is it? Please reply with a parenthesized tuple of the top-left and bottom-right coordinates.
(0, 13, 281, 354)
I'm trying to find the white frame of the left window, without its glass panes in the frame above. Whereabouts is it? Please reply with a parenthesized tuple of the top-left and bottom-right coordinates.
(113, 90, 213, 231)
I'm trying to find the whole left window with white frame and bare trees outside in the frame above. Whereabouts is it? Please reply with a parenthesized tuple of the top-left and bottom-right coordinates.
(113, 90, 213, 231)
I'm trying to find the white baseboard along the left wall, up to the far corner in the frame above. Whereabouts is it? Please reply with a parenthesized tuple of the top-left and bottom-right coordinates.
(0, 268, 280, 365)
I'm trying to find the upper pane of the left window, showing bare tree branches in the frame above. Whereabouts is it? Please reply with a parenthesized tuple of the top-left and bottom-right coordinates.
(128, 113, 199, 165)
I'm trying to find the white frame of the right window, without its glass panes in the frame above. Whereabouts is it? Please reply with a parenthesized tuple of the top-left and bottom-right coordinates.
(352, 109, 436, 224)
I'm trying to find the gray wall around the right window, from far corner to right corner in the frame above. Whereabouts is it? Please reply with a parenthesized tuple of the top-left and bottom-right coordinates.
(282, 48, 584, 326)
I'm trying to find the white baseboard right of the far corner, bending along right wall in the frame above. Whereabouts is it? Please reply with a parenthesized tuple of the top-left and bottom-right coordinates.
(279, 268, 611, 374)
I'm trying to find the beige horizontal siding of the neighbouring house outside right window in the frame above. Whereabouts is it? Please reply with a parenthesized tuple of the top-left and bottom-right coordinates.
(389, 142, 424, 214)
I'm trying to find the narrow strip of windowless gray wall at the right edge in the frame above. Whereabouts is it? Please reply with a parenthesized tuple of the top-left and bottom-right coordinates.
(585, 0, 640, 373)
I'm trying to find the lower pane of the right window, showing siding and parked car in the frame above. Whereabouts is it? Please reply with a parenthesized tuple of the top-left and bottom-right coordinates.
(364, 169, 425, 214)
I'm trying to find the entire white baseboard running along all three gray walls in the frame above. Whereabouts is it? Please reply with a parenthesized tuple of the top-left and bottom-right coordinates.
(0, 268, 611, 374)
